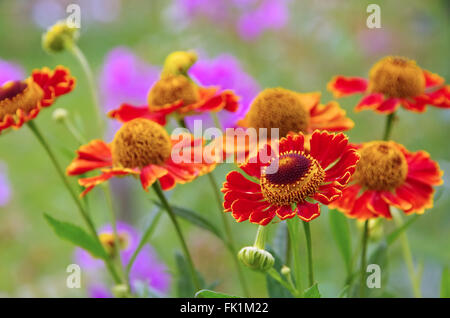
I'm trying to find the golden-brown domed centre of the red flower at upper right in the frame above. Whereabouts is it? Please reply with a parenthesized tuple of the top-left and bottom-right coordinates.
(369, 56, 425, 98)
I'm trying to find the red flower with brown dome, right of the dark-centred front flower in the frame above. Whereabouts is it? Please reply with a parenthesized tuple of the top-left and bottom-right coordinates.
(330, 141, 443, 220)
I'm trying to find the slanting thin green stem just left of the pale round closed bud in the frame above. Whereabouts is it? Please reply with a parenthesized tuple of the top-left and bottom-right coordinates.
(208, 172, 250, 297)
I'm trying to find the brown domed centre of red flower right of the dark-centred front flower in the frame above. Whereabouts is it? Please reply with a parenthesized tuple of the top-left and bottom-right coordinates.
(353, 141, 408, 191)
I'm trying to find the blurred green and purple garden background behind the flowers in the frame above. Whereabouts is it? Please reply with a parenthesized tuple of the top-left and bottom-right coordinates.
(0, 0, 450, 297)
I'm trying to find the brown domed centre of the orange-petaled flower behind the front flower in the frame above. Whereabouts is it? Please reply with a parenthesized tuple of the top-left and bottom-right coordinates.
(247, 88, 309, 137)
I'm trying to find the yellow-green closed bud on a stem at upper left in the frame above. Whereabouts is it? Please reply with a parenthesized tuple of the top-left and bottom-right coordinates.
(42, 20, 78, 53)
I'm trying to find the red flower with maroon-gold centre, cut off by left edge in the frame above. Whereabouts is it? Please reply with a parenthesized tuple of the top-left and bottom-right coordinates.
(0, 66, 75, 132)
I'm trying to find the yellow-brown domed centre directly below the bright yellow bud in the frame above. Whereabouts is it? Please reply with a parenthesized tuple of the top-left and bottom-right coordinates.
(148, 75, 199, 107)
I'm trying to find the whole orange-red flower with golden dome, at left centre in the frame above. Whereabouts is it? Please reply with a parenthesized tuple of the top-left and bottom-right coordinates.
(66, 118, 215, 196)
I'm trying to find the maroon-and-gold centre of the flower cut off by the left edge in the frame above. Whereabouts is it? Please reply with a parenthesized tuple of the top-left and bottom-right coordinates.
(0, 79, 44, 121)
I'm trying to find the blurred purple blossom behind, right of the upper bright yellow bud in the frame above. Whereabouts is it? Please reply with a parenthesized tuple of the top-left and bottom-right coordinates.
(186, 54, 260, 128)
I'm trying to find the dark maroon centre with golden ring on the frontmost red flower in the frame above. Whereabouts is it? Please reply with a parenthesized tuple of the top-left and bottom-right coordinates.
(261, 151, 325, 206)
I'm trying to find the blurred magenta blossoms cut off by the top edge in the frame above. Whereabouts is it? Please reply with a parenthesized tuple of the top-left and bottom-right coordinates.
(174, 0, 289, 41)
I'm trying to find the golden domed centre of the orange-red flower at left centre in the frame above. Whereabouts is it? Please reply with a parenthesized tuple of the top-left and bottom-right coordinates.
(111, 118, 172, 169)
